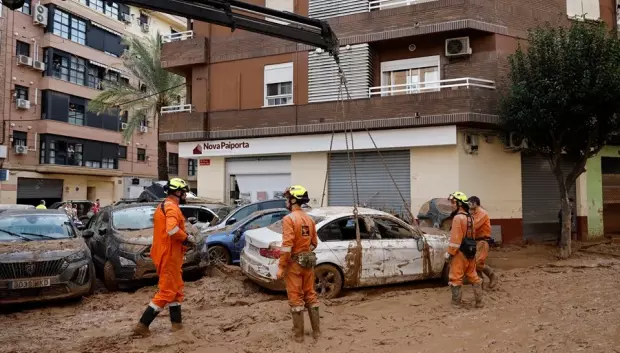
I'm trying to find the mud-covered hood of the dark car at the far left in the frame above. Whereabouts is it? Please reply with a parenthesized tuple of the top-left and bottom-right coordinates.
(0, 238, 88, 261)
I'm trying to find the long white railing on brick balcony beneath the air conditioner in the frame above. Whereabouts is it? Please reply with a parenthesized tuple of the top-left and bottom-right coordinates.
(368, 77, 495, 97)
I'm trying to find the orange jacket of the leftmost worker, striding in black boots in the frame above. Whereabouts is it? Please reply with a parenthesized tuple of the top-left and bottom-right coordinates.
(151, 198, 187, 273)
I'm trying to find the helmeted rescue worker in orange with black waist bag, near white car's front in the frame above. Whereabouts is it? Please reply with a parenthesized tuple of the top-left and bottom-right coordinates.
(446, 191, 483, 308)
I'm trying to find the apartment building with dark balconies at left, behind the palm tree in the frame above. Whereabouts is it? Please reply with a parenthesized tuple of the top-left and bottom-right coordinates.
(0, 0, 194, 205)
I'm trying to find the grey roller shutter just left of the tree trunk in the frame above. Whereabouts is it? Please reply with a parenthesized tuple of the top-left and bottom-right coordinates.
(521, 155, 577, 241)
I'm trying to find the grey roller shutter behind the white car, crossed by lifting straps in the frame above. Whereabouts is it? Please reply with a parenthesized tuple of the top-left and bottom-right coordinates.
(328, 150, 411, 218)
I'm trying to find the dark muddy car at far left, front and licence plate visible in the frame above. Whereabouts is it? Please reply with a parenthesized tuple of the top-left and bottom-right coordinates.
(0, 209, 95, 304)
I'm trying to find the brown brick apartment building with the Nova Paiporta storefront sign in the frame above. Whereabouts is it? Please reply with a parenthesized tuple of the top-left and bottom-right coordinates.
(160, 0, 617, 242)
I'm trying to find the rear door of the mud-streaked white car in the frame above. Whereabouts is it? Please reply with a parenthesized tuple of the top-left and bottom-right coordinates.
(317, 216, 384, 286)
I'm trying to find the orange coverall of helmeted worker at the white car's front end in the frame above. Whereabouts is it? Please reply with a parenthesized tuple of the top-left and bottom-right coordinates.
(448, 213, 482, 286)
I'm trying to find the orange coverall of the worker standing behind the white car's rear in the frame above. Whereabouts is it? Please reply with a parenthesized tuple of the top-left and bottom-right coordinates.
(278, 208, 319, 311)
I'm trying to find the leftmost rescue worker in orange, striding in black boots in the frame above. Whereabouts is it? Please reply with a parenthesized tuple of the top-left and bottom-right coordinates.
(134, 178, 196, 336)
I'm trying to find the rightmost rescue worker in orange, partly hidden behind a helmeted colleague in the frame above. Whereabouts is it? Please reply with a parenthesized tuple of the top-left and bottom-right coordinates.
(469, 196, 497, 289)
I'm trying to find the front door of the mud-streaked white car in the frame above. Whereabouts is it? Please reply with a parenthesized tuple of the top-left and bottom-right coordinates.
(372, 216, 424, 283)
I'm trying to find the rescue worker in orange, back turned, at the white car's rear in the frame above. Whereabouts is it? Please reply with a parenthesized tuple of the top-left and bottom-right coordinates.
(277, 185, 321, 342)
